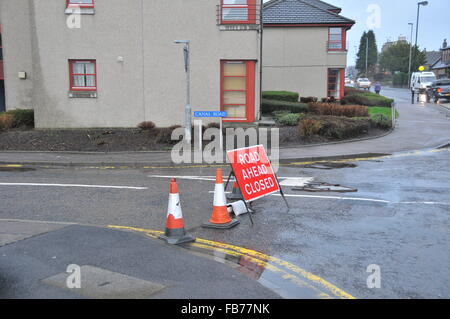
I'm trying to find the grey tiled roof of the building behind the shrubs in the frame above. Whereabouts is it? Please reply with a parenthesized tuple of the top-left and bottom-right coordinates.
(263, 0, 355, 24)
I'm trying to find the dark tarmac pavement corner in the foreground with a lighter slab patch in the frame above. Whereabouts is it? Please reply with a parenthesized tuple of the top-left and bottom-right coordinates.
(0, 221, 280, 299)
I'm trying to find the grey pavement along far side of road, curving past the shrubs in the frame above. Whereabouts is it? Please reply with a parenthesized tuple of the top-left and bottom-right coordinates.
(0, 89, 450, 166)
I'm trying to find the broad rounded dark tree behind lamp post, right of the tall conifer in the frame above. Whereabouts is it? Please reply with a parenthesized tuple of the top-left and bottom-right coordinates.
(380, 42, 426, 74)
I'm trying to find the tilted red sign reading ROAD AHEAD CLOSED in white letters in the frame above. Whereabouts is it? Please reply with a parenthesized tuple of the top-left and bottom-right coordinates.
(227, 145, 280, 201)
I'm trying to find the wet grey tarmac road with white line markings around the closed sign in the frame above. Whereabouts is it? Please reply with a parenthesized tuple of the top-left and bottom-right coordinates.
(0, 149, 450, 298)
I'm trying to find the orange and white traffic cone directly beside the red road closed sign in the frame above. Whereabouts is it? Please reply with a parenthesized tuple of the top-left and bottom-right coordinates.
(202, 168, 239, 229)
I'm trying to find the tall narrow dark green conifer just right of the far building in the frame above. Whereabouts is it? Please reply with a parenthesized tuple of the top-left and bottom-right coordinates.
(356, 30, 378, 76)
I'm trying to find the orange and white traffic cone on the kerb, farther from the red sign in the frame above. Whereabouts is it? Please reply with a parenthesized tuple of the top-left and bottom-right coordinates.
(160, 178, 195, 245)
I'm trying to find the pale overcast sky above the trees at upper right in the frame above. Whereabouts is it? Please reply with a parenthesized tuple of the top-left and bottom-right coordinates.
(265, 0, 450, 65)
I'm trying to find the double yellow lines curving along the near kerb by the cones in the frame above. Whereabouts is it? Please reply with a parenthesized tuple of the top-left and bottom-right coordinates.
(108, 225, 355, 299)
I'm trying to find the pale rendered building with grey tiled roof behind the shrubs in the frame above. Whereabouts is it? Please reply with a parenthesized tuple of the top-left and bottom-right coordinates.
(262, 0, 355, 99)
